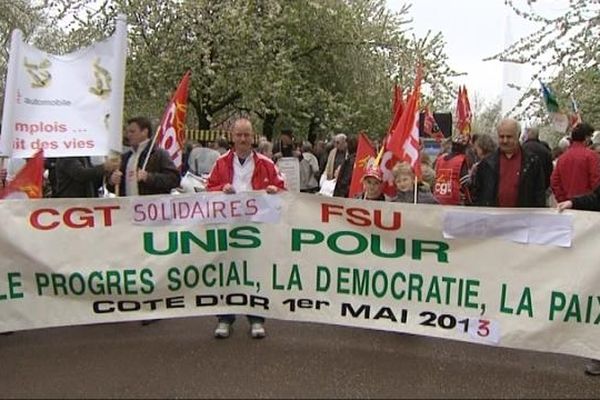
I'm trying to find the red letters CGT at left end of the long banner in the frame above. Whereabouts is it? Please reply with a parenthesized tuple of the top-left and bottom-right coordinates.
(29, 206, 121, 231)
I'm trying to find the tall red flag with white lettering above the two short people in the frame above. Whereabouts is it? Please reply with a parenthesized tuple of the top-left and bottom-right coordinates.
(386, 67, 423, 178)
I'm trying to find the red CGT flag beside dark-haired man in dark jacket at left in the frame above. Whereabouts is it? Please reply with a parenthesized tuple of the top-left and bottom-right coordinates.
(154, 71, 191, 169)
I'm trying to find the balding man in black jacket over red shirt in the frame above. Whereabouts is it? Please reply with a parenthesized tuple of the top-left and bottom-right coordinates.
(473, 119, 546, 207)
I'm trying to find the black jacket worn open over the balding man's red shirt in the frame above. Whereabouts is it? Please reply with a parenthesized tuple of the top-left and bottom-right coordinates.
(473, 149, 546, 207)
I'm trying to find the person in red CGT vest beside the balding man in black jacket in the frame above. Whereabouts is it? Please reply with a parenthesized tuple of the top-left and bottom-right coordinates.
(433, 134, 471, 206)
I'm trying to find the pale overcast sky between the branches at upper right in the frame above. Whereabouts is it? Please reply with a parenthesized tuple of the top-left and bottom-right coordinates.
(387, 0, 568, 108)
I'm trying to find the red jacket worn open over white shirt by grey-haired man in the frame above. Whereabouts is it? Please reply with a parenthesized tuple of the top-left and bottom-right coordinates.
(206, 150, 285, 192)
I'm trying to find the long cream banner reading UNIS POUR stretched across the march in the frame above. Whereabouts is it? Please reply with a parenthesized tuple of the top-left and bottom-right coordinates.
(0, 192, 600, 358)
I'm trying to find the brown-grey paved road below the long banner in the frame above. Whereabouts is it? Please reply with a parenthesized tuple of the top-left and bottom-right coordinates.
(0, 317, 600, 398)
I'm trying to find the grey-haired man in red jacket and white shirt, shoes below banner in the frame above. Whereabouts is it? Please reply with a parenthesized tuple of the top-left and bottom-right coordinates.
(206, 118, 285, 339)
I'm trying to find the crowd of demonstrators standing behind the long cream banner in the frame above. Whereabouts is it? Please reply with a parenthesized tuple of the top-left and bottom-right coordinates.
(5, 104, 600, 375)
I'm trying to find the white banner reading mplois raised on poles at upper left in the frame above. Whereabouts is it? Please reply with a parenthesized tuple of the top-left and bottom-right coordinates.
(0, 16, 127, 158)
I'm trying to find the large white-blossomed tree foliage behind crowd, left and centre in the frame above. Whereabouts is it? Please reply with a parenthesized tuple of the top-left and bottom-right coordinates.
(0, 0, 455, 139)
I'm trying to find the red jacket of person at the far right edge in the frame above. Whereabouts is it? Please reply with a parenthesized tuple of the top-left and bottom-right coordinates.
(550, 142, 600, 202)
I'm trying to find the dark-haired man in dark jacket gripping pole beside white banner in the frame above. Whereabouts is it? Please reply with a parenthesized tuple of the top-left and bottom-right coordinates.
(110, 117, 180, 196)
